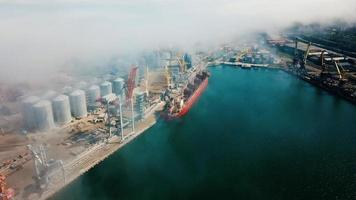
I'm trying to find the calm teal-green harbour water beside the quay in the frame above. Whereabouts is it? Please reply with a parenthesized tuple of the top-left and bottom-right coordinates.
(54, 67, 356, 200)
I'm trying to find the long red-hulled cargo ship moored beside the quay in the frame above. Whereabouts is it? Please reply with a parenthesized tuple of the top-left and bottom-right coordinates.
(166, 70, 210, 119)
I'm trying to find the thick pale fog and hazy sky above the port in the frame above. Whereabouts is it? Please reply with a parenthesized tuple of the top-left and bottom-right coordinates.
(0, 0, 356, 81)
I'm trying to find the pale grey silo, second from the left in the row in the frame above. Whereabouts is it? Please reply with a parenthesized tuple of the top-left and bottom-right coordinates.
(33, 100, 54, 131)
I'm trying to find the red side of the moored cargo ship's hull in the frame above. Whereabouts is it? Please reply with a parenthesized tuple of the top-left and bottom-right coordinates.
(169, 78, 209, 119)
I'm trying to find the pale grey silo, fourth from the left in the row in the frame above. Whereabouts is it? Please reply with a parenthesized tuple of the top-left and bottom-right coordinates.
(69, 90, 87, 117)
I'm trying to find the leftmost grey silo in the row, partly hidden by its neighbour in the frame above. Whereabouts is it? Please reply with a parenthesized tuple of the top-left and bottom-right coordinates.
(22, 96, 40, 130)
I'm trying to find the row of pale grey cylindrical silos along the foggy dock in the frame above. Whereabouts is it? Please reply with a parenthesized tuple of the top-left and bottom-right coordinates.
(22, 78, 125, 131)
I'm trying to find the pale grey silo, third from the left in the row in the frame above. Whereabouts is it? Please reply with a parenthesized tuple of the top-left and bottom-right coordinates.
(52, 95, 72, 125)
